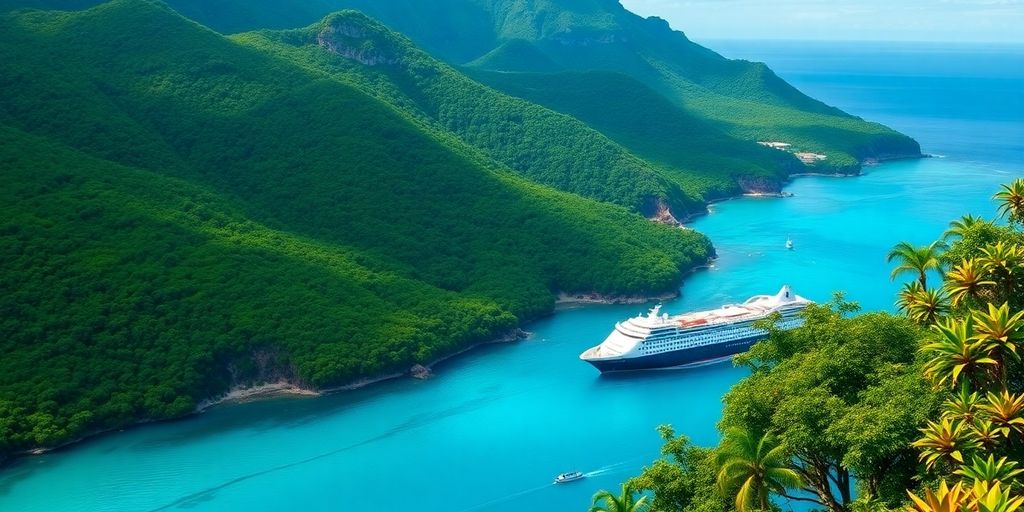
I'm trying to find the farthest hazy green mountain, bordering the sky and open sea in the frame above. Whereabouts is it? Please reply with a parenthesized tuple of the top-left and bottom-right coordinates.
(123, 0, 921, 174)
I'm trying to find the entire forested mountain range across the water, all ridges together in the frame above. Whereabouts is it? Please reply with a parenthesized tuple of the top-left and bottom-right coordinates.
(0, 0, 918, 466)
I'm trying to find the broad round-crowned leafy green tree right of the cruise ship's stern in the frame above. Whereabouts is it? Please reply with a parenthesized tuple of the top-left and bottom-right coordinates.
(722, 306, 940, 511)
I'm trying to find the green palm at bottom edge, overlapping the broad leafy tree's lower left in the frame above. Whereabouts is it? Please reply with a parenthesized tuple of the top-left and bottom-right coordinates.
(718, 428, 802, 512)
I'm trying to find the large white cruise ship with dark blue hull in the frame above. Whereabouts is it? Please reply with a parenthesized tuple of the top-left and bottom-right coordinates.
(580, 285, 812, 372)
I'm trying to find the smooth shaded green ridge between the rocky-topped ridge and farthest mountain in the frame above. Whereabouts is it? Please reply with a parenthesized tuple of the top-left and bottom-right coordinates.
(467, 70, 806, 200)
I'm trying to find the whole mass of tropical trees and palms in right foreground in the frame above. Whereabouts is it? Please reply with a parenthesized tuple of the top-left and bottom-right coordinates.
(592, 179, 1024, 512)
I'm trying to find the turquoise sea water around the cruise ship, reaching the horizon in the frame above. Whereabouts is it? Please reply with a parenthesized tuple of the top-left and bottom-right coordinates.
(0, 43, 1024, 512)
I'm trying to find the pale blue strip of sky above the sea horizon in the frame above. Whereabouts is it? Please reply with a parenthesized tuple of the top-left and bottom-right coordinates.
(622, 0, 1024, 43)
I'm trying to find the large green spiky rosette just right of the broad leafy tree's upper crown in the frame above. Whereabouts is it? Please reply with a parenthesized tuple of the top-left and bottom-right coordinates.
(921, 318, 996, 387)
